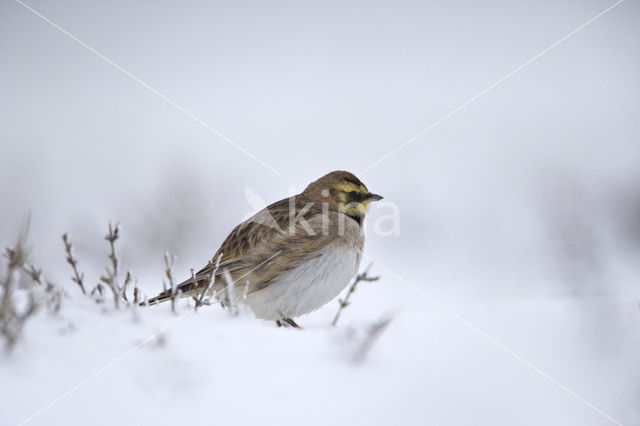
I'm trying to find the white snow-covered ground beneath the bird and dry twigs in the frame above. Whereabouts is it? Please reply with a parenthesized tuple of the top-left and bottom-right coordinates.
(0, 258, 640, 425)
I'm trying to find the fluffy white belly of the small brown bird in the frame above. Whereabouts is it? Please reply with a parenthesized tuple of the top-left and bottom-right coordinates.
(246, 244, 361, 320)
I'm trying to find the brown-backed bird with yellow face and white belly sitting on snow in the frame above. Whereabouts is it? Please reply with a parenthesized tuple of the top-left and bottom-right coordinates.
(142, 170, 383, 327)
